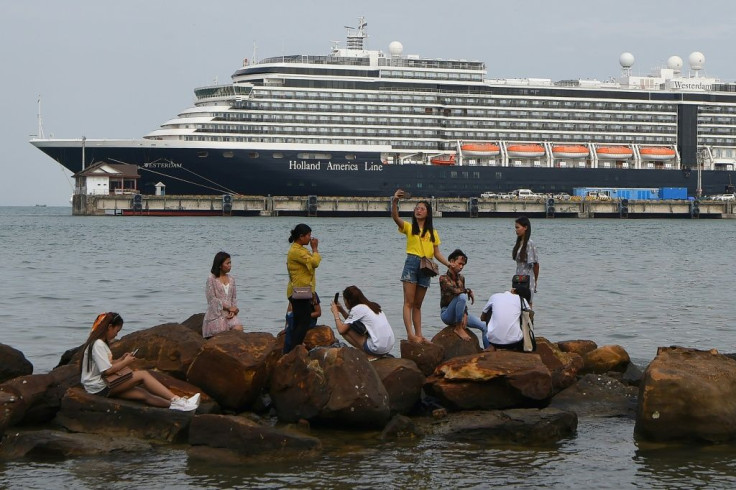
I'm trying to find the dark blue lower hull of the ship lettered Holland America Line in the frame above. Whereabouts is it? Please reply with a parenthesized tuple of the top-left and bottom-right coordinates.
(33, 144, 736, 197)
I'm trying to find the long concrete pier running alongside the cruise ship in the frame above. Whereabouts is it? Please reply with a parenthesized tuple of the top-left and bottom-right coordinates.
(72, 194, 736, 219)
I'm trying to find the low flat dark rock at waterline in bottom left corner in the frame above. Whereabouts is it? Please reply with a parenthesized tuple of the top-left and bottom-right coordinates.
(0, 429, 152, 461)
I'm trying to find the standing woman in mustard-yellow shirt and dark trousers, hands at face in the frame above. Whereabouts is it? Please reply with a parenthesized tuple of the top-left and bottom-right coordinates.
(284, 223, 322, 354)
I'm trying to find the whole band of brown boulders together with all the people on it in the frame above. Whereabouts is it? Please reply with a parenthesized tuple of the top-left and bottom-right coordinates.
(0, 190, 736, 462)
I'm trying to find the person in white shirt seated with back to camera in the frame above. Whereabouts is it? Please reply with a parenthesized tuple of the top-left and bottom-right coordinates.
(480, 286, 531, 352)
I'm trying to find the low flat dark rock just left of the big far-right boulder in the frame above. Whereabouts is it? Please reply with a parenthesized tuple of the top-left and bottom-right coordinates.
(549, 374, 639, 418)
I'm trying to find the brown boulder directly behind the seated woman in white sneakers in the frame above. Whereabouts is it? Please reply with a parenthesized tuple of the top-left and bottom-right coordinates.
(110, 323, 204, 379)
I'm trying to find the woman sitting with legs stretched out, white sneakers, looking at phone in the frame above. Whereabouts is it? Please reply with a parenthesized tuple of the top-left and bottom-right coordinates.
(81, 312, 200, 412)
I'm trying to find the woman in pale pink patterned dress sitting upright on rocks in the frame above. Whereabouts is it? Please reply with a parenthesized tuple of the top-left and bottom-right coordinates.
(202, 252, 243, 338)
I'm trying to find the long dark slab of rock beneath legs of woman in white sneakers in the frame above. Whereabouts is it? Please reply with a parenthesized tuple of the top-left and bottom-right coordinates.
(55, 387, 204, 442)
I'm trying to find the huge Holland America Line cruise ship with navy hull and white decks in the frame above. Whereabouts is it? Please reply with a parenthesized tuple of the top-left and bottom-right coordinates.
(31, 18, 736, 197)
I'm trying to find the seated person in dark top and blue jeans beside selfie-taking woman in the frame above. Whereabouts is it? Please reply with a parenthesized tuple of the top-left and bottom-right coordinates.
(440, 249, 489, 349)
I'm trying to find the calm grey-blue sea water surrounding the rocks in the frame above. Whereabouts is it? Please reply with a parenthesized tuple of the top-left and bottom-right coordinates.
(0, 207, 736, 488)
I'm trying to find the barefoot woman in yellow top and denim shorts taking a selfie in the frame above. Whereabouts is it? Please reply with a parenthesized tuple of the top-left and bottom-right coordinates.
(391, 189, 450, 342)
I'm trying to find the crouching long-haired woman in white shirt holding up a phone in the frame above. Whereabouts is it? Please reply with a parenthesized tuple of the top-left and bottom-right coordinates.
(330, 286, 396, 357)
